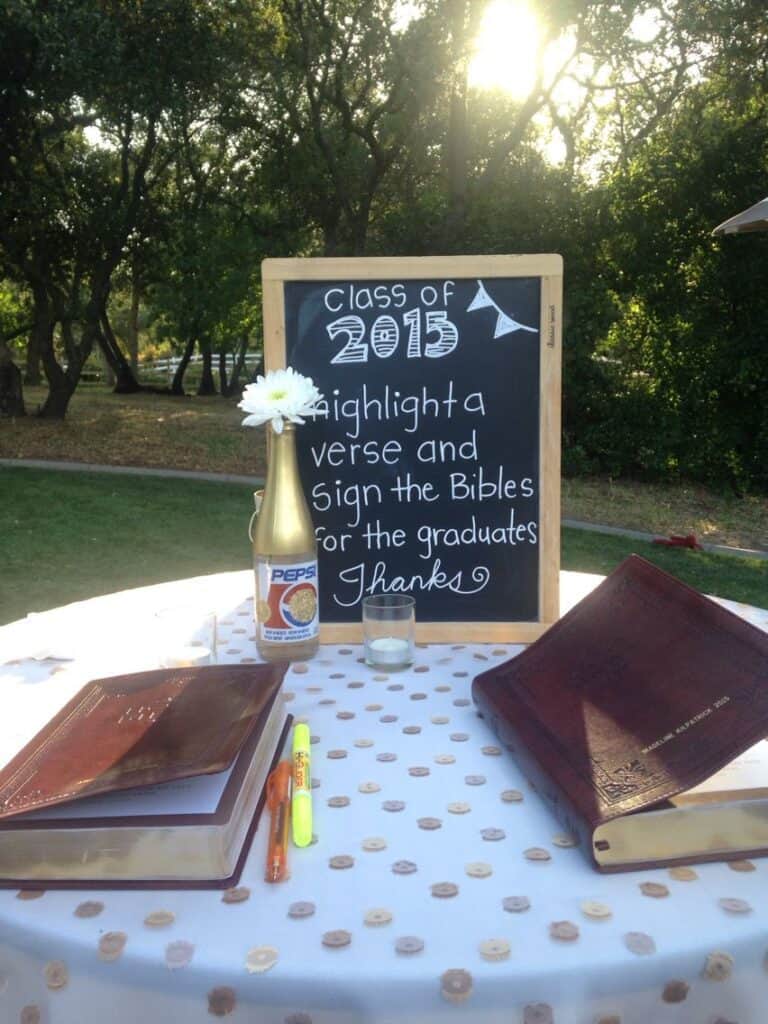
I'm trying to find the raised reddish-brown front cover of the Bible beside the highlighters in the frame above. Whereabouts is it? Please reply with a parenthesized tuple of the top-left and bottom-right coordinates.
(0, 664, 287, 819)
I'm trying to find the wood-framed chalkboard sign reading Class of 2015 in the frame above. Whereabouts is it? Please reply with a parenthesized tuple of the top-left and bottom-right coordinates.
(262, 255, 562, 642)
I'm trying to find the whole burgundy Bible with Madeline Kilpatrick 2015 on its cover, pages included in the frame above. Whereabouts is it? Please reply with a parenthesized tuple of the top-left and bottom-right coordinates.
(472, 555, 768, 871)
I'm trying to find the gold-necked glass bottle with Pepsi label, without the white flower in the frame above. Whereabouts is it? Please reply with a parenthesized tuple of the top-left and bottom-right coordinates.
(253, 423, 319, 662)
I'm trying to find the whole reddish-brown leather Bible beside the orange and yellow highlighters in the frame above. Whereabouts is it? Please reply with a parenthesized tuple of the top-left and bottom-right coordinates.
(0, 664, 290, 889)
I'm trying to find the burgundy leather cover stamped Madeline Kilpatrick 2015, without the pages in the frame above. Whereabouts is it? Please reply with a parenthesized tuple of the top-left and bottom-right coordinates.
(472, 555, 768, 868)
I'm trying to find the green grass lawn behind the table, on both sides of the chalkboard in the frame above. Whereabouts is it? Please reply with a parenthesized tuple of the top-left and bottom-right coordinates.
(0, 468, 768, 624)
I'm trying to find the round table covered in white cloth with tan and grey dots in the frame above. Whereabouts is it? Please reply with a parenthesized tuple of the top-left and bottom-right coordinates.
(0, 572, 768, 1024)
